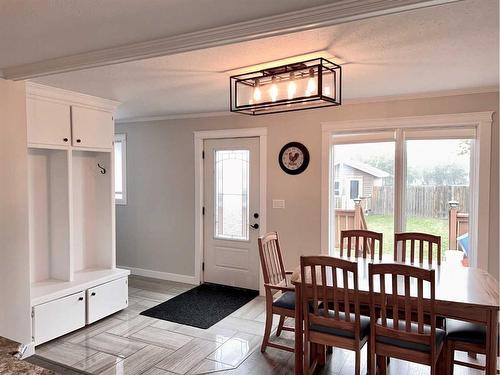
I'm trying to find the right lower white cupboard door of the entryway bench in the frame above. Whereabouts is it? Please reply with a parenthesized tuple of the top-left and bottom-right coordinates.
(87, 277, 128, 324)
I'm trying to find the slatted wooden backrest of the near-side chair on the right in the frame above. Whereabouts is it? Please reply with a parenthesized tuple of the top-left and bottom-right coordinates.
(368, 263, 436, 356)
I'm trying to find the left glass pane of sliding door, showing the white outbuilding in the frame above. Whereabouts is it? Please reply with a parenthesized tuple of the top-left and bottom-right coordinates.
(332, 142, 395, 254)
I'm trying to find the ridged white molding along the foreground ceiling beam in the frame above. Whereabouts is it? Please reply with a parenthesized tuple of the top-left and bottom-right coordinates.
(2, 0, 463, 80)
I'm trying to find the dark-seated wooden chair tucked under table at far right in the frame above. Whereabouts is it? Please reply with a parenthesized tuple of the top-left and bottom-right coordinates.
(446, 318, 488, 375)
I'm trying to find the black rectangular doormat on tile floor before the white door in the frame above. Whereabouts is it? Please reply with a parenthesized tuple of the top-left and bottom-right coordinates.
(141, 283, 259, 329)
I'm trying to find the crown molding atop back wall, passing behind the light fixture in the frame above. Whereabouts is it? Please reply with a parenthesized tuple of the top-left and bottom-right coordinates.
(115, 86, 500, 125)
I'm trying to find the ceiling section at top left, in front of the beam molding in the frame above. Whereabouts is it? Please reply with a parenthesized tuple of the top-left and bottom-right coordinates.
(0, 0, 332, 68)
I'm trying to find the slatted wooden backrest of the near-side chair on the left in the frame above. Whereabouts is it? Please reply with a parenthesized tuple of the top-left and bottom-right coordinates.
(300, 256, 360, 340)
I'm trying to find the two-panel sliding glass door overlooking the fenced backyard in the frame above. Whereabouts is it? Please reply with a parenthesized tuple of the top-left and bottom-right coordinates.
(330, 129, 475, 265)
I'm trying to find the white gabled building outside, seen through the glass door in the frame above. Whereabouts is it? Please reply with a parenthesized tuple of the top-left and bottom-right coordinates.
(334, 160, 390, 209)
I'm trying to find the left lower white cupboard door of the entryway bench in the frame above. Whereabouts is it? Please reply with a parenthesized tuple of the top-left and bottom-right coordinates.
(33, 291, 85, 345)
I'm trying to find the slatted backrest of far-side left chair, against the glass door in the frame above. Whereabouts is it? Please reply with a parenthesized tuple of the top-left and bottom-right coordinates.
(340, 229, 384, 260)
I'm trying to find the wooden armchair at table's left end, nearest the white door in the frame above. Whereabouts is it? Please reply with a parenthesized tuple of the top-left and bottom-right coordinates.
(258, 232, 295, 352)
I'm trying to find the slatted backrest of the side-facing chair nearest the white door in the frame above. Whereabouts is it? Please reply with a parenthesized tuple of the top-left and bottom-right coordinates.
(259, 232, 287, 286)
